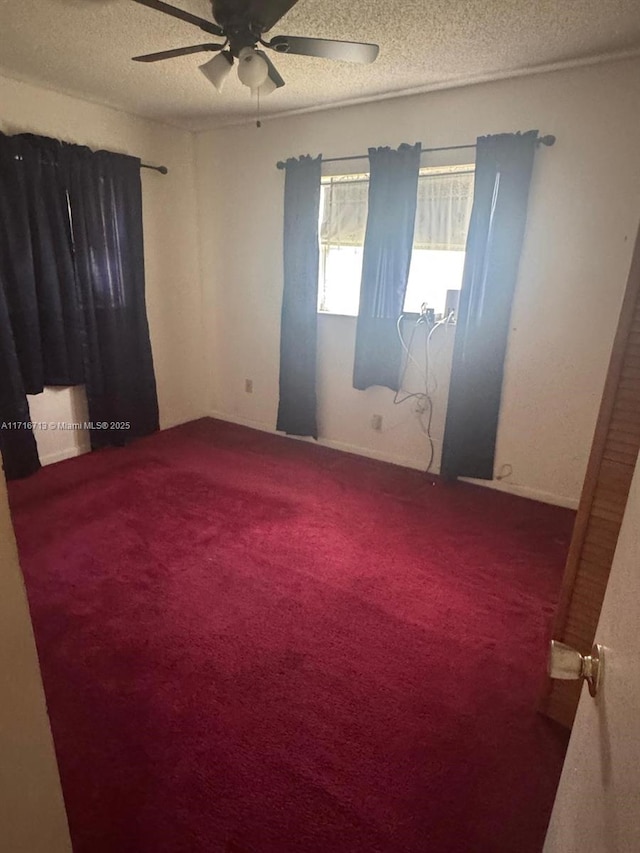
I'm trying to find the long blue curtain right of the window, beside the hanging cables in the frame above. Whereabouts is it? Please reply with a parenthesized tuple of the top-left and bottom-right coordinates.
(441, 130, 538, 480)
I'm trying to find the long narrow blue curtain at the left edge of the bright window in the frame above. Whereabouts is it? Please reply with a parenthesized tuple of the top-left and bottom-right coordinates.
(276, 157, 322, 438)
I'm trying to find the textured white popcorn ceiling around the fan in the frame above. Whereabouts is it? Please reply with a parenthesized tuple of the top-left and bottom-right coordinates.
(0, 0, 640, 130)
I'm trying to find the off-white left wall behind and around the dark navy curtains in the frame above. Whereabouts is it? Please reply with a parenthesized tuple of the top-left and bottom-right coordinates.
(0, 77, 207, 464)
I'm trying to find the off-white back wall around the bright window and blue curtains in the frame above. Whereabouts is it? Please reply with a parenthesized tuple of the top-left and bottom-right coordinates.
(196, 60, 640, 505)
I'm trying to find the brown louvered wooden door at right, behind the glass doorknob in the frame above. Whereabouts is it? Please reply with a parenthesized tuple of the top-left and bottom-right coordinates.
(542, 218, 640, 726)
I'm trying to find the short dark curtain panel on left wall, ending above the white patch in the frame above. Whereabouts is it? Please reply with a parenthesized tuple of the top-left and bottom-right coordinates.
(0, 134, 82, 394)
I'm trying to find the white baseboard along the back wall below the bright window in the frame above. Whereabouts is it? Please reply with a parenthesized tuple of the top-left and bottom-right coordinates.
(209, 411, 579, 509)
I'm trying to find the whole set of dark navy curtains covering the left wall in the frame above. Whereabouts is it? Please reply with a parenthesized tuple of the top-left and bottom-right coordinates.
(0, 133, 158, 479)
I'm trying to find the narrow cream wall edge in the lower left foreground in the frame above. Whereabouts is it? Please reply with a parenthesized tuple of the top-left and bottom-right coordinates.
(0, 470, 71, 853)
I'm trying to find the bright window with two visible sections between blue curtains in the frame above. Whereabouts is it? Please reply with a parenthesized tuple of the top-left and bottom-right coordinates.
(318, 165, 474, 316)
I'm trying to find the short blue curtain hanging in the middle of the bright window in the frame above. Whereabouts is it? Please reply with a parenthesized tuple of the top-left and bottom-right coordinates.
(353, 142, 422, 391)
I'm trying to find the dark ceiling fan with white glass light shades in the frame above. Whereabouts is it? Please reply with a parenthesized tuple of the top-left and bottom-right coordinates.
(133, 0, 379, 95)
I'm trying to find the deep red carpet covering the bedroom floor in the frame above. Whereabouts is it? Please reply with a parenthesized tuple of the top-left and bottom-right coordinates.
(11, 420, 573, 853)
